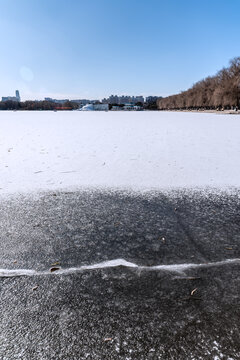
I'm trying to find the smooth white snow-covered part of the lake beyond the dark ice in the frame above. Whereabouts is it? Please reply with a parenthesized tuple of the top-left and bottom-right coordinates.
(0, 111, 240, 194)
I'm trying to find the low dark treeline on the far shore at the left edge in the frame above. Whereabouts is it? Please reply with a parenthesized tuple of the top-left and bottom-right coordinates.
(0, 100, 79, 110)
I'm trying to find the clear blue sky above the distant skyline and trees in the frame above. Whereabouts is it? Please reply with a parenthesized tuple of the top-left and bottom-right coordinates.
(0, 0, 240, 99)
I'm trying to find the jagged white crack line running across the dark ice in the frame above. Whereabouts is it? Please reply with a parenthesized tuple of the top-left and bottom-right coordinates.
(0, 258, 240, 277)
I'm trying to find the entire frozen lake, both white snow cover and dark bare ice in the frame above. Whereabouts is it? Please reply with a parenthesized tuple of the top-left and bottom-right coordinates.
(0, 111, 240, 360)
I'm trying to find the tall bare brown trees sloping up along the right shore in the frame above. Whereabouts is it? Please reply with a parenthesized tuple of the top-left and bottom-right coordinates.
(157, 57, 240, 110)
